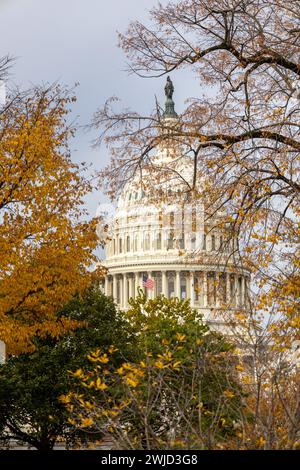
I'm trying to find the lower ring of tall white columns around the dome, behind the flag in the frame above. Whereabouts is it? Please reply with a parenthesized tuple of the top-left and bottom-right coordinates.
(104, 271, 247, 308)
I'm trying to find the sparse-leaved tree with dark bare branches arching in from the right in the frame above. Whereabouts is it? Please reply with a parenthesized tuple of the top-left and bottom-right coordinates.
(92, 0, 300, 448)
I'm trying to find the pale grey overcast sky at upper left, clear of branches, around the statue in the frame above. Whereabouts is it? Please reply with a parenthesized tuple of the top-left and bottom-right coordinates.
(0, 0, 199, 215)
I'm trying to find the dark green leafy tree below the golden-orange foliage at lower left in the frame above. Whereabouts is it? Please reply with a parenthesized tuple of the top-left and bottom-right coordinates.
(0, 286, 134, 450)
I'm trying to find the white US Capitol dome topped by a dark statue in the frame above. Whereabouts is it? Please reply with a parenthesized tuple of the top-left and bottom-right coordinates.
(102, 77, 250, 329)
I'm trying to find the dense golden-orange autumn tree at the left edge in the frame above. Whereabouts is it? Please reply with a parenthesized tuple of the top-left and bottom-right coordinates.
(0, 81, 101, 354)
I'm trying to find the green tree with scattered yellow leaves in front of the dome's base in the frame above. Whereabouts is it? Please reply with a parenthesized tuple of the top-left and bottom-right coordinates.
(62, 292, 242, 449)
